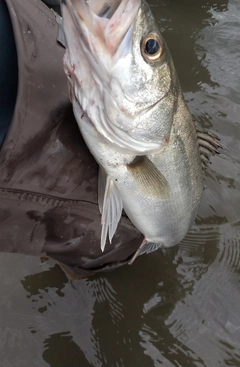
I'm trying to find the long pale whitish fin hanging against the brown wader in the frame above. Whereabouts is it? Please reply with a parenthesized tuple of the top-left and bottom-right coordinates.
(98, 170, 123, 251)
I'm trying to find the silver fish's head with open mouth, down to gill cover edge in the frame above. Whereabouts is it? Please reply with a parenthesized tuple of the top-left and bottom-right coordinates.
(62, 0, 179, 155)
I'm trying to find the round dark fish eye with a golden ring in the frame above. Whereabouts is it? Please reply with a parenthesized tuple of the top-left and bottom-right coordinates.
(141, 32, 163, 62)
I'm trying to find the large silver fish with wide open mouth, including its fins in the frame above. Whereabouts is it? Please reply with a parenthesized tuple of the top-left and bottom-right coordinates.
(62, 0, 219, 261)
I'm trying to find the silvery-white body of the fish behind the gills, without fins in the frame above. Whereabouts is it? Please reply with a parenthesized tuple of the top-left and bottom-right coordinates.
(75, 100, 202, 247)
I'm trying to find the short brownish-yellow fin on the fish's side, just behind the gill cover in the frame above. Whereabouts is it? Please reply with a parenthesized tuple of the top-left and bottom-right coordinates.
(127, 156, 170, 200)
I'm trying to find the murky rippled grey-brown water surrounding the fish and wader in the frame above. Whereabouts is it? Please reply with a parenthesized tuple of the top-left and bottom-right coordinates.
(0, 0, 240, 367)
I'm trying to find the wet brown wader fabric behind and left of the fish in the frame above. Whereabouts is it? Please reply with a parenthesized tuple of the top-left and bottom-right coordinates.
(0, 0, 142, 276)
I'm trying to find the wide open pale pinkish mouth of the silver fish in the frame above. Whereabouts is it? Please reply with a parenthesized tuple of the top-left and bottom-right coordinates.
(62, 0, 141, 56)
